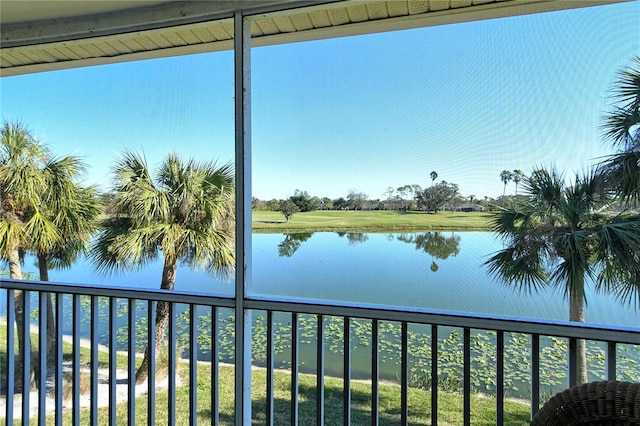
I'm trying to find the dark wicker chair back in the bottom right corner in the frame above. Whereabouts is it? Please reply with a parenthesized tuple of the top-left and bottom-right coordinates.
(531, 381, 640, 426)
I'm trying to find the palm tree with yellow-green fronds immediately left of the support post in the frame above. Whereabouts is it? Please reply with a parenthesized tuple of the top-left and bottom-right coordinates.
(90, 152, 234, 383)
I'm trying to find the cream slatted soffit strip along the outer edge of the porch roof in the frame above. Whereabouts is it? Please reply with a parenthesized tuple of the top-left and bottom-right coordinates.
(0, 0, 621, 75)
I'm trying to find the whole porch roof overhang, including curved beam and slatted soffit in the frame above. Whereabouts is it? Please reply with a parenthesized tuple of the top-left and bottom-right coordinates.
(0, 0, 618, 76)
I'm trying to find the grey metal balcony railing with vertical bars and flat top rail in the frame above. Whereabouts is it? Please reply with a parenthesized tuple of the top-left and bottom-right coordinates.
(0, 280, 640, 425)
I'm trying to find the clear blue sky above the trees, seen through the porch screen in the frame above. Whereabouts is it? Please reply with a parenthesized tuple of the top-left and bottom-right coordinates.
(0, 1, 640, 199)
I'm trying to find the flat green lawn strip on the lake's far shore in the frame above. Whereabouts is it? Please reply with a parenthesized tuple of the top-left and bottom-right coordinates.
(252, 210, 491, 232)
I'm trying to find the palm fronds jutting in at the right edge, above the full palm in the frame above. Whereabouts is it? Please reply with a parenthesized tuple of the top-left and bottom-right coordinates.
(603, 57, 640, 202)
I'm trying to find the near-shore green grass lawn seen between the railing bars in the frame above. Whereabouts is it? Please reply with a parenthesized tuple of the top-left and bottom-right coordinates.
(0, 324, 529, 425)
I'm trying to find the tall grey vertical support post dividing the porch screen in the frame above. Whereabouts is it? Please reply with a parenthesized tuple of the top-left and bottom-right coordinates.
(234, 12, 251, 426)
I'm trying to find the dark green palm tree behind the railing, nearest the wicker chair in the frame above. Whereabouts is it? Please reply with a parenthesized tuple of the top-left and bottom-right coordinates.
(485, 170, 640, 383)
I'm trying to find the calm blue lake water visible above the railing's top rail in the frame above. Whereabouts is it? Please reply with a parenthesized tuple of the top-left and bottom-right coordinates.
(11, 232, 640, 326)
